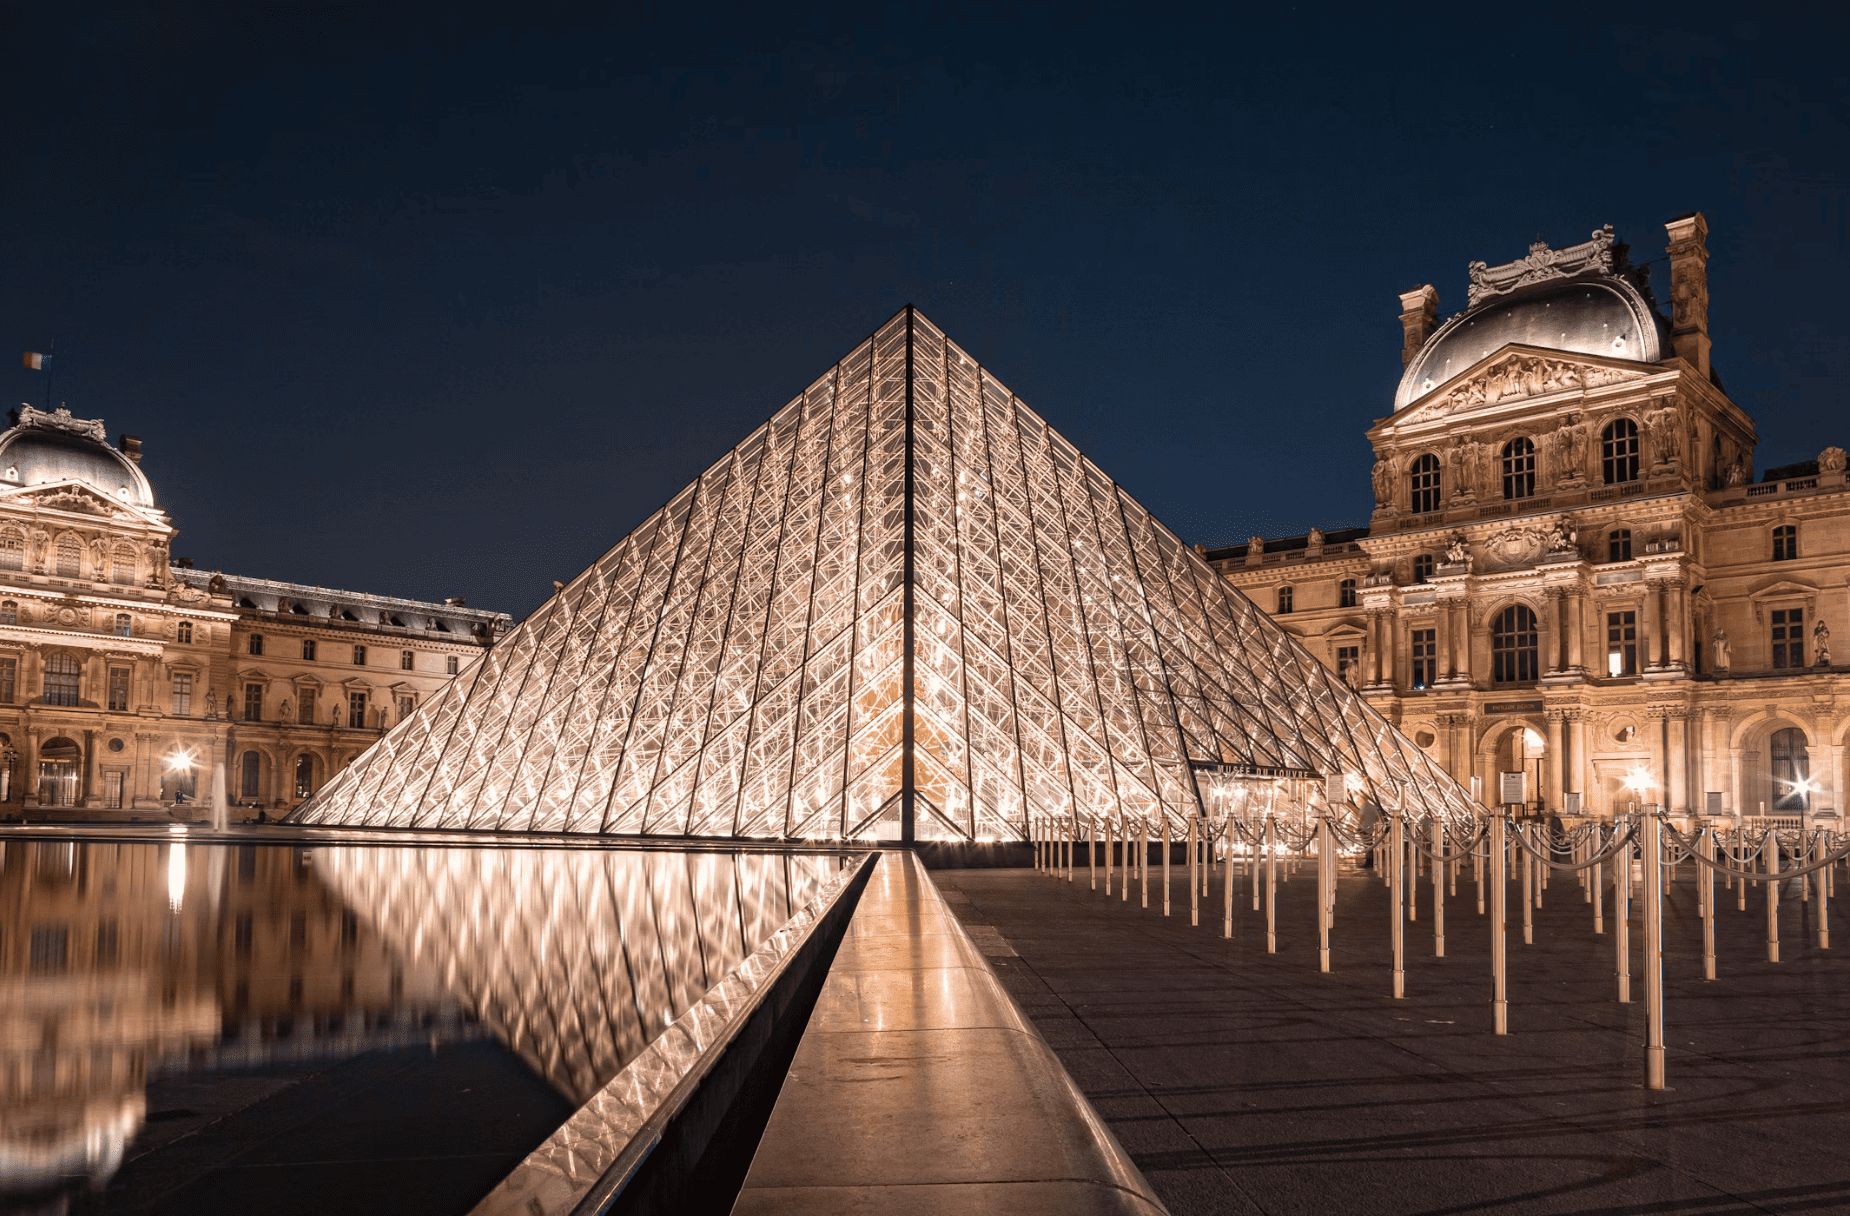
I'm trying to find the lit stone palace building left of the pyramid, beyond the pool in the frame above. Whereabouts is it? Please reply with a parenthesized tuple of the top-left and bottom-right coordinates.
(0, 405, 509, 818)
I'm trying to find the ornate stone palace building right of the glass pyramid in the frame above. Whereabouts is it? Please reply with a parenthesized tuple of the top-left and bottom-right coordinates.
(1206, 215, 1850, 816)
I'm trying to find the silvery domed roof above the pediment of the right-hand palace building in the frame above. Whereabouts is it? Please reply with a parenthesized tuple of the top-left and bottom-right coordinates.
(1393, 274, 1663, 409)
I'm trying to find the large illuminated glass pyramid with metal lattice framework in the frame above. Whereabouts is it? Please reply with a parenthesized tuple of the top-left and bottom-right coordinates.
(296, 309, 1469, 840)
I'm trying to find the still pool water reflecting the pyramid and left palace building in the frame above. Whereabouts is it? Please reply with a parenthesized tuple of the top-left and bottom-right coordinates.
(0, 838, 840, 1214)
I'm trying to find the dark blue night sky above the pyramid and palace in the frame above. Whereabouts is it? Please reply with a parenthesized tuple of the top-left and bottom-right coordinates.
(0, 4, 1850, 616)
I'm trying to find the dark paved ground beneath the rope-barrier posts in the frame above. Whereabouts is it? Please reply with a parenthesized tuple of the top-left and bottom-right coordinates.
(932, 864, 1850, 1216)
